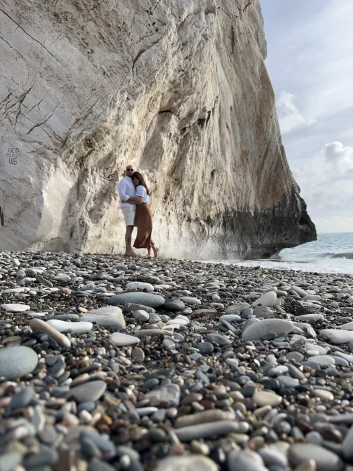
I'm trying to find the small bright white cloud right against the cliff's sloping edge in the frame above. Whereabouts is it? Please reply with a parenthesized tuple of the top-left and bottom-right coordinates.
(277, 91, 315, 134)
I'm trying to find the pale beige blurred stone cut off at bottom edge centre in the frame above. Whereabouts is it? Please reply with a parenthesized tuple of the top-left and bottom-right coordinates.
(155, 455, 218, 471)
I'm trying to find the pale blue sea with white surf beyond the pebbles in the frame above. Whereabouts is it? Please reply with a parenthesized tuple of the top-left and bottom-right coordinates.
(212, 232, 353, 275)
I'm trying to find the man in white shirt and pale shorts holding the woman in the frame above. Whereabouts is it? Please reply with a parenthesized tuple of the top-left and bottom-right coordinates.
(118, 165, 136, 257)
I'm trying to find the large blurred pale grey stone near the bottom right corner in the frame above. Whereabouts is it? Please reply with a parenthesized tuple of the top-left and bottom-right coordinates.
(288, 443, 344, 471)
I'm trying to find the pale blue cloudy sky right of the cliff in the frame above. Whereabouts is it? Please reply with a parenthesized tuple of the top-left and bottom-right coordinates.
(260, 0, 353, 233)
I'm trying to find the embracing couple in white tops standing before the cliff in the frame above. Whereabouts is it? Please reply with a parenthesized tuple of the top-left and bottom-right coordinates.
(118, 165, 159, 257)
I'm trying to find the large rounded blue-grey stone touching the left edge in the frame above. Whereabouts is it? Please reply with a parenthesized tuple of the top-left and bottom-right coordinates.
(0, 346, 38, 379)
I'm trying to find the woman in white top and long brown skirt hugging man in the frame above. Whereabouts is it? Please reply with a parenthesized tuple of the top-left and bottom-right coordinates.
(132, 172, 159, 257)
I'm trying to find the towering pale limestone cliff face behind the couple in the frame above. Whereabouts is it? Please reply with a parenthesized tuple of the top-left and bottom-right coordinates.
(0, 0, 316, 258)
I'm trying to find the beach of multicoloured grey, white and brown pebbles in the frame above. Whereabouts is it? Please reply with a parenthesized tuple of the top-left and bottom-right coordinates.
(0, 252, 353, 471)
